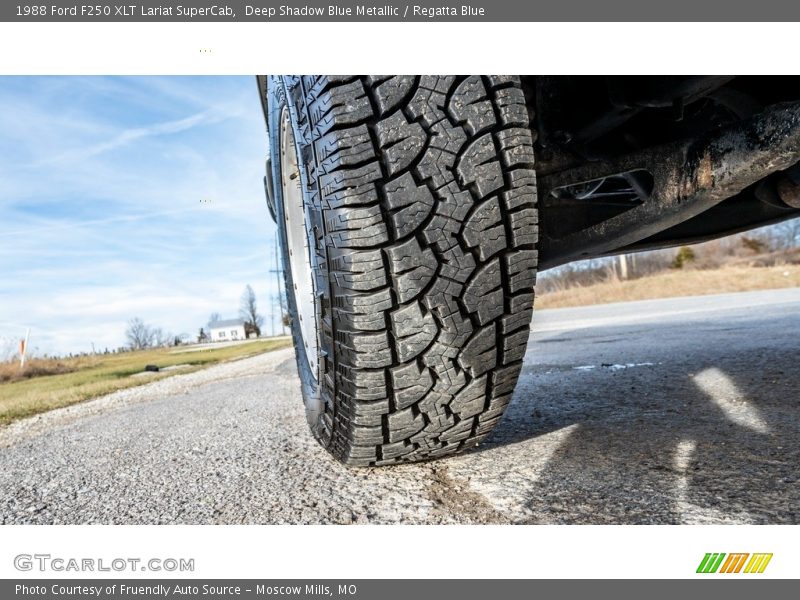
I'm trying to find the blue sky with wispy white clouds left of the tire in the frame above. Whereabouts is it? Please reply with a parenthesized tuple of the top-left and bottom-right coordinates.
(0, 77, 276, 354)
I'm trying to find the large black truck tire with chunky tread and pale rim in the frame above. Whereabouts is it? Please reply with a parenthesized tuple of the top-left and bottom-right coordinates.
(266, 76, 537, 466)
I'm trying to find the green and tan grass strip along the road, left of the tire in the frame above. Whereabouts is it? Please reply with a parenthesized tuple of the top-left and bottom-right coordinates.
(0, 338, 291, 425)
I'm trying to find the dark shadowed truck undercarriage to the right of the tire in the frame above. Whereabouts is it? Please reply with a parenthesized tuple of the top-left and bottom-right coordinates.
(522, 76, 800, 269)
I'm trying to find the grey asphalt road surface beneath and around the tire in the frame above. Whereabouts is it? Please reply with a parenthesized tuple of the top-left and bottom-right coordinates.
(0, 289, 800, 523)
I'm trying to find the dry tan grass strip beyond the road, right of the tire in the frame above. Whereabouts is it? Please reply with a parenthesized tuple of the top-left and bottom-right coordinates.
(536, 265, 800, 308)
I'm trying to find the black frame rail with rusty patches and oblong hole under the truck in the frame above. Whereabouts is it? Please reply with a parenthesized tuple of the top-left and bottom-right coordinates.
(539, 103, 800, 268)
